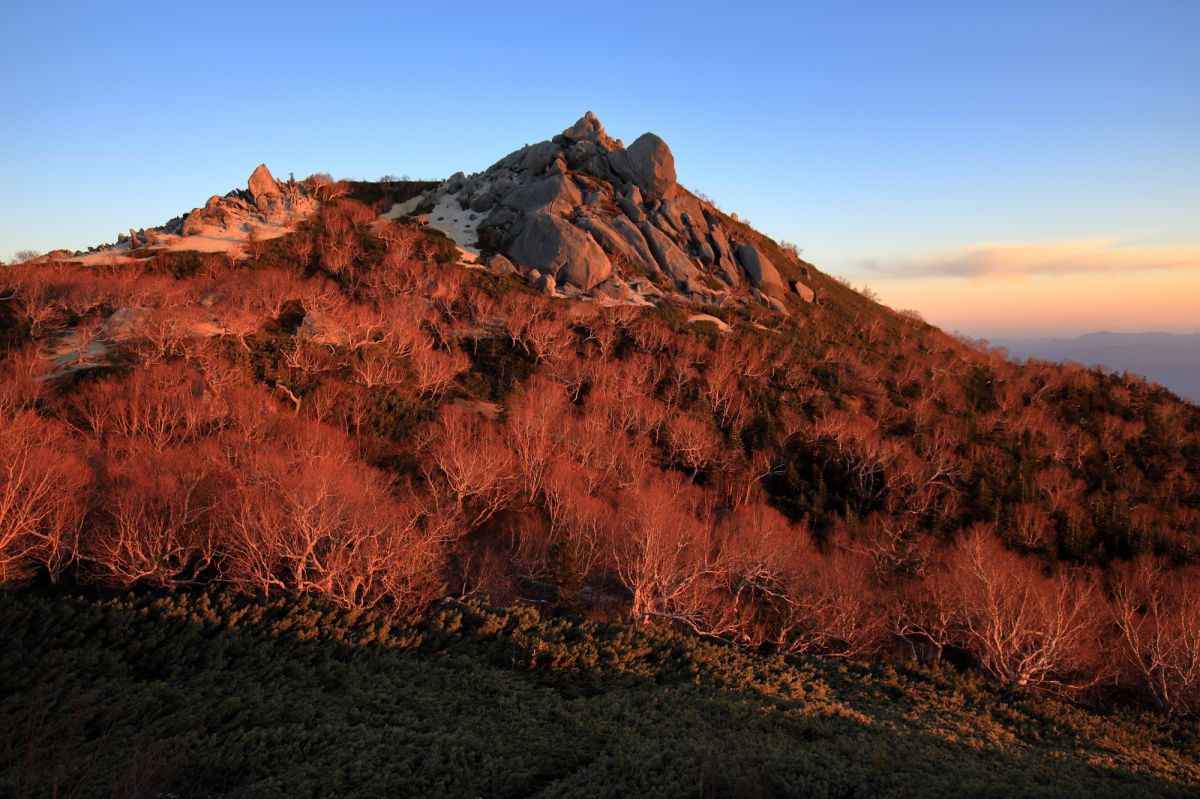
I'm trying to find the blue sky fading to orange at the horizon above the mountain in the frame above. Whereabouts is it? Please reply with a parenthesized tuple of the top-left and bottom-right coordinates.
(0, 0, 1200, 336)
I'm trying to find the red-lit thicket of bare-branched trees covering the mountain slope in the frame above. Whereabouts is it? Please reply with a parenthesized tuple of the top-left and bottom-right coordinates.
(0, 199, 1200, 713)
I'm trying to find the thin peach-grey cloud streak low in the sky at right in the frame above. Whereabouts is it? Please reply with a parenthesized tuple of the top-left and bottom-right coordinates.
(863, 241, 1200, 278)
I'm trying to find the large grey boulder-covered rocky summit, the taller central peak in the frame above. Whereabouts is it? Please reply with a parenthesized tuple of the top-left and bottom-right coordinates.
(402, 112, 815, 311)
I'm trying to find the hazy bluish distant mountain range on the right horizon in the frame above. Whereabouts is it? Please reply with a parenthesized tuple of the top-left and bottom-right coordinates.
(990, 330, 1200, 402)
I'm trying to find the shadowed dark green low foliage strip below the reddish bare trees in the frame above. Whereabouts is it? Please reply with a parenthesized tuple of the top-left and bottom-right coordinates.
(0, 591, 1200, 799)
